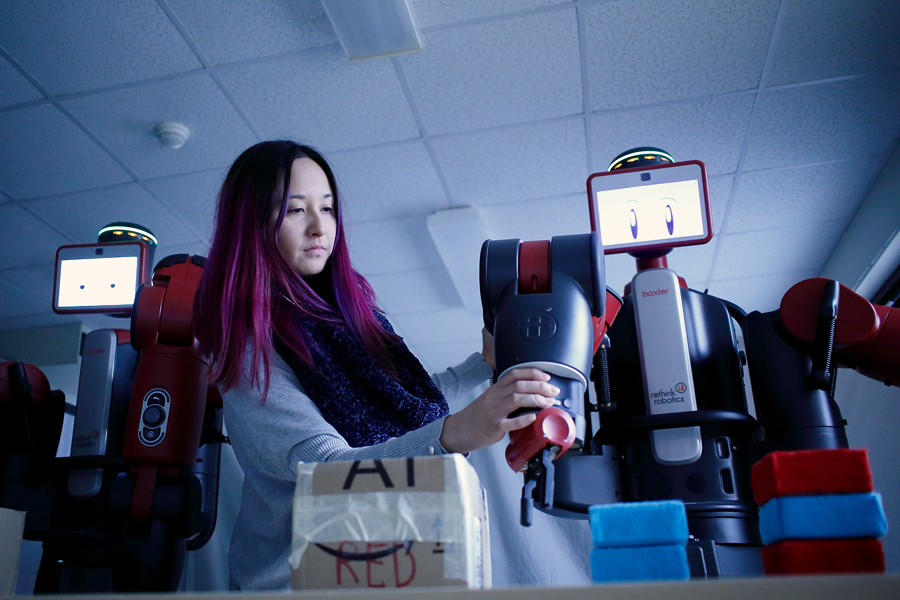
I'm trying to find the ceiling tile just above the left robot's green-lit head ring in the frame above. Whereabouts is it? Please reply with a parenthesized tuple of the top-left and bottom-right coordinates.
(26, 183, 197, 244)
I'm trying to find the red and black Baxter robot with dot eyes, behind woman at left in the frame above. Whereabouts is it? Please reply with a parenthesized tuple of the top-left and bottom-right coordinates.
(0, 223, 224, 594)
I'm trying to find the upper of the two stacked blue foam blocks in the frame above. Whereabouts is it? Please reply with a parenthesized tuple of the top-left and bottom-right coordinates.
(588, 500, 688, 548)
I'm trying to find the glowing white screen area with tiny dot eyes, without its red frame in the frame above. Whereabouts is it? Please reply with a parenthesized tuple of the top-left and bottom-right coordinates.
(57, 256, 138, 308)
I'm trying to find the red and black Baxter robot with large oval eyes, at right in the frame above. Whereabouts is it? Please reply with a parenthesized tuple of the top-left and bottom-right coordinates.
(480, 148, 900, 577)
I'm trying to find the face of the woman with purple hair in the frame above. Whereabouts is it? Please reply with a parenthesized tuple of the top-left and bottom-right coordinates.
(276, 157, 337, 277)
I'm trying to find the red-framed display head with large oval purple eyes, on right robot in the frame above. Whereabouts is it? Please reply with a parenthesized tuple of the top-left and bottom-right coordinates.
(588, 161, 712, 254)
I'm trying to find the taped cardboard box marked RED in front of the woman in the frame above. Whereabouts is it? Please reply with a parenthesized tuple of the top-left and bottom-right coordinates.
(291, 454, 491, 590)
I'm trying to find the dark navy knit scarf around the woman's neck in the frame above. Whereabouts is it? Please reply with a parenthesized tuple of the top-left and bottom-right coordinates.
(275, 313, 449, 448)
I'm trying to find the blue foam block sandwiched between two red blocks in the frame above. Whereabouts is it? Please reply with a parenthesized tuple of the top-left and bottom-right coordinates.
(759, 492, 887, 544)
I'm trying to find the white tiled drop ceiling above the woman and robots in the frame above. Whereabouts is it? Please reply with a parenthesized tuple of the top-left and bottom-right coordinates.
(0, 0, 900, 370)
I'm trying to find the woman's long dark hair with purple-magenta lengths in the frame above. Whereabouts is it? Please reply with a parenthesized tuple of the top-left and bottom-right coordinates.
(194, 141, 398, 401)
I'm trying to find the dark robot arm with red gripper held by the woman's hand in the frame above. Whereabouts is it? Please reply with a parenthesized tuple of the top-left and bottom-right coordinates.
(480, 233, 614, 525)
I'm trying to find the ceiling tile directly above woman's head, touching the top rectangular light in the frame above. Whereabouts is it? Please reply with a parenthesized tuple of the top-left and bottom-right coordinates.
(219, 46, 419, 150)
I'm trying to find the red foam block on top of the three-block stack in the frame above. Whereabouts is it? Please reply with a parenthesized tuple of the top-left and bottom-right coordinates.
(750, 448, 872, 506)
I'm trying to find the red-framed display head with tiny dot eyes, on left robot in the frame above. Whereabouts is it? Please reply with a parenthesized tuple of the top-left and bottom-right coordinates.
(53, 244, 146, 314)
